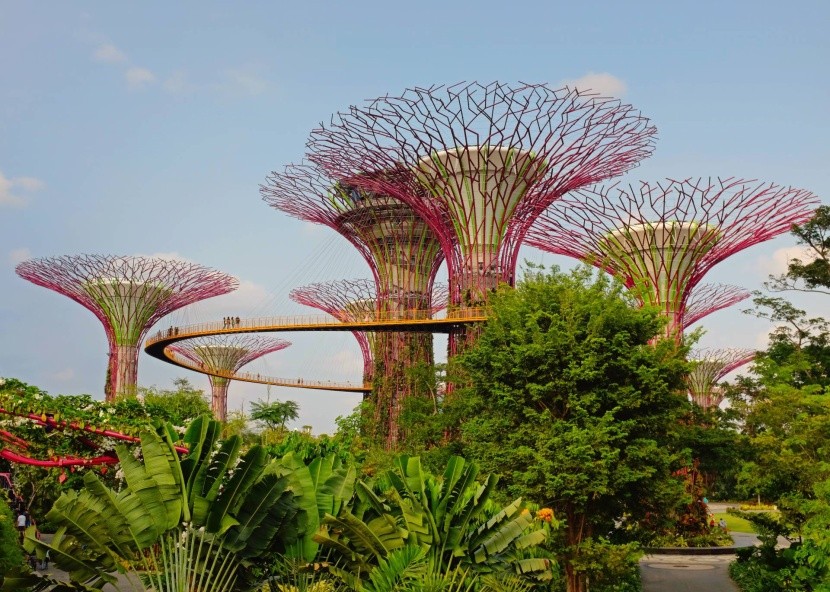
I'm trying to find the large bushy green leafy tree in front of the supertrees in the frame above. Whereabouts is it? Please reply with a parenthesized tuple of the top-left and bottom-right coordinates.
(452, 268, 687, 592)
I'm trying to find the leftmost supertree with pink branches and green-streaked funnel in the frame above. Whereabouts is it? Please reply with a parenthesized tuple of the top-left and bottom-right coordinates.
(16, 255, 238, 401)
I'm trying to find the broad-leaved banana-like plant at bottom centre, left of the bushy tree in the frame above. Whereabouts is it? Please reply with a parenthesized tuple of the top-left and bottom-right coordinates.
(315, 456, 551, 578)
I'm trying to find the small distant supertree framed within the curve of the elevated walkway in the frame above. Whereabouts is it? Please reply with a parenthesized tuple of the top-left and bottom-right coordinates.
(170, 333, 291, 421)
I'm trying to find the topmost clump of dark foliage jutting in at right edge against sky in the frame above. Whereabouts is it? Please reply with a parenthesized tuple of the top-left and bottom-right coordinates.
(767, 206, 830, 294)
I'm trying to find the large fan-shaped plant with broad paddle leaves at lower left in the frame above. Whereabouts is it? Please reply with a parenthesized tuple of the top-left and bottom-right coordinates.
(4, 417, 299, 592)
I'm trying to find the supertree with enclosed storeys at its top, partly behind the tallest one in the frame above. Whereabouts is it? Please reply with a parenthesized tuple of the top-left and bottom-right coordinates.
(261, 164, 452, 445)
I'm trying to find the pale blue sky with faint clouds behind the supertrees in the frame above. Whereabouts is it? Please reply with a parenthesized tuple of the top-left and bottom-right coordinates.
(0, 0, 830, 433)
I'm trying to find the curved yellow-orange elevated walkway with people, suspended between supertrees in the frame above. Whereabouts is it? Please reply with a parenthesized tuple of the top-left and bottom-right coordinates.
(144, 307, 487, 393)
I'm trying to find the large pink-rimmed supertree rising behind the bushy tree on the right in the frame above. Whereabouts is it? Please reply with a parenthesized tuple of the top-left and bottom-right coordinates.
(527, 178, 818, 339)
